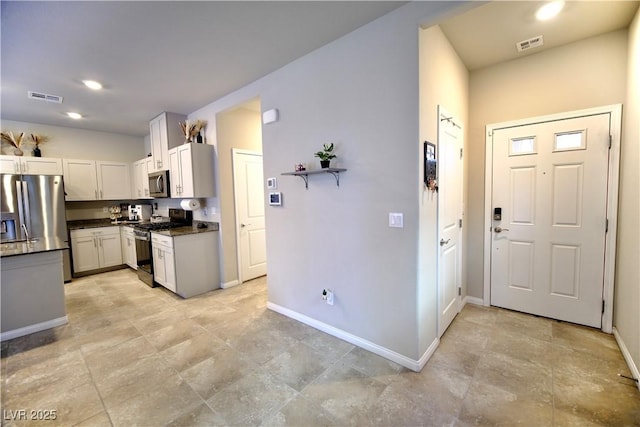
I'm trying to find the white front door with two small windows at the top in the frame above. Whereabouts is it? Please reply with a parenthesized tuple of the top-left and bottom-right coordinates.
(491, 114, 610, 328)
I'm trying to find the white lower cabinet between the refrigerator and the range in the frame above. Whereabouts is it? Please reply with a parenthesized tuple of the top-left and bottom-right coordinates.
(70, 227, 122, 273)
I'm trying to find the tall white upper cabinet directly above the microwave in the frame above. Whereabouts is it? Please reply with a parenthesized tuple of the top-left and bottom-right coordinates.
(149, 112, 182, 172)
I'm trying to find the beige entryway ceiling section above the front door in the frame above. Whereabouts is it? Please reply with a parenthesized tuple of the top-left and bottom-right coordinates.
(440, 0, 639, 71)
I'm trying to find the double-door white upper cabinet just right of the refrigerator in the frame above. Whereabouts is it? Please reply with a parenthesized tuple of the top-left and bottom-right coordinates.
(63, 159, 131, 201)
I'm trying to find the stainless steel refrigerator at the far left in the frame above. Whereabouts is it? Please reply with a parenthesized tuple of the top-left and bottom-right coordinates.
(0, 174, 71, 282)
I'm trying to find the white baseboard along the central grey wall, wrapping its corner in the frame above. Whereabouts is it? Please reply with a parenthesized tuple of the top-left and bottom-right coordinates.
(267, 302, 440, 372)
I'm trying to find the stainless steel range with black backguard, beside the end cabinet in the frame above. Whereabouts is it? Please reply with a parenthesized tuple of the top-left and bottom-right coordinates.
(133, 209, 193, 287)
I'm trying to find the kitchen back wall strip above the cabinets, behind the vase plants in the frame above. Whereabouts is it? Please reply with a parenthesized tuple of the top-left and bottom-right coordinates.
(1, 120, 147, 163)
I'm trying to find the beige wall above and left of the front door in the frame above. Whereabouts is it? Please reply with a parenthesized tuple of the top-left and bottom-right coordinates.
(466, 30, 627, 298)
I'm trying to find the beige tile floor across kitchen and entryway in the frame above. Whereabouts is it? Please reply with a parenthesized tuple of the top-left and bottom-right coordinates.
(1, 270, 640, 427)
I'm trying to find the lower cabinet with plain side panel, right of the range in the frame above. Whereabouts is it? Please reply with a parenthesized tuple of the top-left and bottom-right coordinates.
(151, 232, 220, 298)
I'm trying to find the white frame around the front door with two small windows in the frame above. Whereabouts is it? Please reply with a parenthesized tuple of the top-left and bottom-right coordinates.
(483, 104, 622, 333)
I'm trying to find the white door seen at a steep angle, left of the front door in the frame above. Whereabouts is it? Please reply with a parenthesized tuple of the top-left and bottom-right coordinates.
(437, 107, 463, 336)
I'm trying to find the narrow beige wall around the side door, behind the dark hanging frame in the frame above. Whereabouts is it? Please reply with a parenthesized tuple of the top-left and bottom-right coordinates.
(417, 25, 469, 353)
